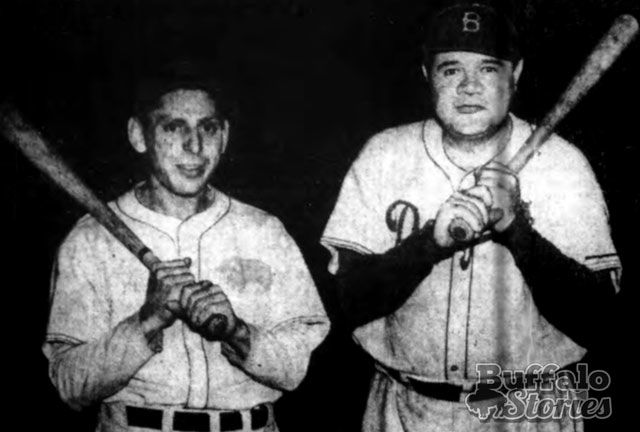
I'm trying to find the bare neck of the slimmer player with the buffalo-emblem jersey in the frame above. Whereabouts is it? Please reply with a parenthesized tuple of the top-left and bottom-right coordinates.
(135, 177, 215, 220)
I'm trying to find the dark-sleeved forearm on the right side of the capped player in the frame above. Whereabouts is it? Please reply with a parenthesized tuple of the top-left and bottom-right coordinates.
(496, 214, 615, 348)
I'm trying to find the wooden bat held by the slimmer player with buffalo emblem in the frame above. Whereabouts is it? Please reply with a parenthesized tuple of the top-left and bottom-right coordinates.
(0, 104, 226, 330)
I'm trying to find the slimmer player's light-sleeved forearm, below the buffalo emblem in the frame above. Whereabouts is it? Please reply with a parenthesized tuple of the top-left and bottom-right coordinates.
(222, 316, 329, 390)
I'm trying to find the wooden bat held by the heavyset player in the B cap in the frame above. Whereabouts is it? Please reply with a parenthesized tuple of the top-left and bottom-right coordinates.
(449, 15, 638, 242)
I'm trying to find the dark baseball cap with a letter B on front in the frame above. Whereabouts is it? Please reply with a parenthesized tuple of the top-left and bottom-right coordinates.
(423, 0, 520, 63)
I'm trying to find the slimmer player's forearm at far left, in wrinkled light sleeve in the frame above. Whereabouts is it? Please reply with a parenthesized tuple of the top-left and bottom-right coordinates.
(49, 314, 155, 409)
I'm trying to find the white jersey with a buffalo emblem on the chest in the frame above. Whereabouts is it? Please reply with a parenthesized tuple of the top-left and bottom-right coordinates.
(44, 187, 329, 430)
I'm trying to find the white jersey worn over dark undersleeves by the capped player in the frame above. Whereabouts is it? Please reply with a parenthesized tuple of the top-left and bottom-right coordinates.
(322, 115, 620, 430)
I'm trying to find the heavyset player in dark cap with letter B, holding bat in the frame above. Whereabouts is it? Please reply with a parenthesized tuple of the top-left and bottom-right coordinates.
(322, 1, 621, 432)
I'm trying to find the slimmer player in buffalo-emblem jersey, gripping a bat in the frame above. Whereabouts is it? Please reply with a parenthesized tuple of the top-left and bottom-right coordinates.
(44, 60, 329, 431)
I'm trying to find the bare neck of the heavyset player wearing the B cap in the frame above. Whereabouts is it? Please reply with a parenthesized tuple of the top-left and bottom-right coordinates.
(443, 117, 511, 171)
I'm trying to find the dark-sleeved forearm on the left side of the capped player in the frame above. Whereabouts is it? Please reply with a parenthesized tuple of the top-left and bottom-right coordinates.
(336, 223, 453, 328)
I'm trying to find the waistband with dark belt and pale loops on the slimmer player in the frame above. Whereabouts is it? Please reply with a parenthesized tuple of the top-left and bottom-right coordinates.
(100, 402, 274, 432)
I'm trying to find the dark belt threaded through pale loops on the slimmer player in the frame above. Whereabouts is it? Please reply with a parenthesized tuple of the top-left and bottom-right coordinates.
(126, 404, 269, 432)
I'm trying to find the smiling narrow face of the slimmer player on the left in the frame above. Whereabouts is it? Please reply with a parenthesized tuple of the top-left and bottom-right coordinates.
(134, 90, 227, 197)
